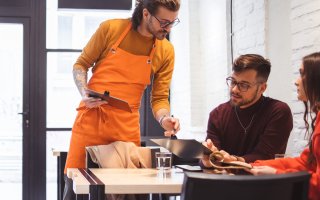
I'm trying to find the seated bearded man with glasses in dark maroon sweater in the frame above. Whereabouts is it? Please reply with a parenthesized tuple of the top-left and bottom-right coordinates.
(202, 54, 293, 167)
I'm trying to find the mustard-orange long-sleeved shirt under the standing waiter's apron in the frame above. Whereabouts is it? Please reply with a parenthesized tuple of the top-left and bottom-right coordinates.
(74, 19, 174, 113)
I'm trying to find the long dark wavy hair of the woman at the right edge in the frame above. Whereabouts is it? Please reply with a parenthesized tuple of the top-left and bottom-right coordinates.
(302, 52, 320, 164)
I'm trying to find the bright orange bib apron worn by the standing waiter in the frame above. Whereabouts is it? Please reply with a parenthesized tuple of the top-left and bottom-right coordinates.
(65, 23, 157, 173)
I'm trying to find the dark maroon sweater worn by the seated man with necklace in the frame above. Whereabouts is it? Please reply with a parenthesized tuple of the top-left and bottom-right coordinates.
(207, 97, 293, 162)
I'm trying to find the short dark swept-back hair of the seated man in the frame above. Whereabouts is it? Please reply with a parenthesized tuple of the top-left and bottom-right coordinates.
(232, 54, 271, 81)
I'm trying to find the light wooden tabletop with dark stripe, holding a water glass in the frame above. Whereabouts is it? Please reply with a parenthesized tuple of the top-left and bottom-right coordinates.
(67, 168, 184, 200)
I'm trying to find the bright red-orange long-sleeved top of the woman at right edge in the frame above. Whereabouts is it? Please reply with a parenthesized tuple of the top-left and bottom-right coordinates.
(252, 113, 320, 200)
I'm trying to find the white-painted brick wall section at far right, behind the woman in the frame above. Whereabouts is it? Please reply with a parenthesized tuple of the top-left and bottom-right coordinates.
(288, 0, 320, 153)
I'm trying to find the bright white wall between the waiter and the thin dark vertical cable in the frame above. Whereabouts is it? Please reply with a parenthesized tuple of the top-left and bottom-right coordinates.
(170, 0, 229, 140)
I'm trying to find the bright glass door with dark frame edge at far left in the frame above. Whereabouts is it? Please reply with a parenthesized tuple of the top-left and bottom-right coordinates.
(0, 18, 29, 200)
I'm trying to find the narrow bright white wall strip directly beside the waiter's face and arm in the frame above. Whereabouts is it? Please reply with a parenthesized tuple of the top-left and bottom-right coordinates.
(170, 1, 191, 137)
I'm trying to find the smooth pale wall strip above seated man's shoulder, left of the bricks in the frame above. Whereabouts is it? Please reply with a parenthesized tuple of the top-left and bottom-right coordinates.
(266, 0, 293, 107)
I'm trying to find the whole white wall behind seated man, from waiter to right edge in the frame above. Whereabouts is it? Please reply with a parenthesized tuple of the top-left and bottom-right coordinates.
(171, 0, 320, 154)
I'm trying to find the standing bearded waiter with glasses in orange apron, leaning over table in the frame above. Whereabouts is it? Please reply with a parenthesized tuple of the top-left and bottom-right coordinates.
(64, 0, 180, 199)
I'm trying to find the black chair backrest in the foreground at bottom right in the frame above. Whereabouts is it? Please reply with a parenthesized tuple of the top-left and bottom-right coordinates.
(181, 172, 310, 200)
